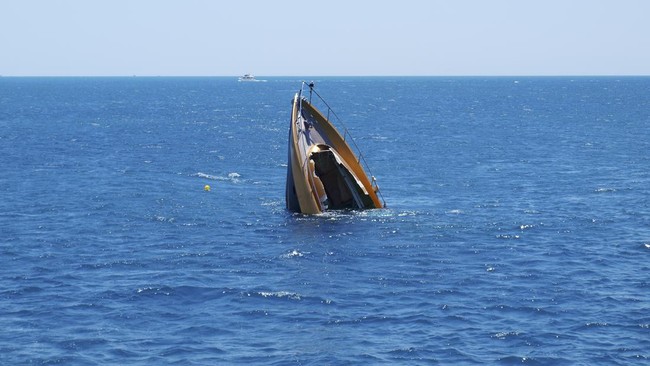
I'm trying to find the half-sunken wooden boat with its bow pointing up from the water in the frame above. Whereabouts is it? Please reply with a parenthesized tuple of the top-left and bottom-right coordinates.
(286, 82, 385, 214)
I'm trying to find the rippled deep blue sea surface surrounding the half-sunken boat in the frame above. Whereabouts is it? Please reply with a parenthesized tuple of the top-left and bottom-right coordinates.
(0, 77, 650, 365)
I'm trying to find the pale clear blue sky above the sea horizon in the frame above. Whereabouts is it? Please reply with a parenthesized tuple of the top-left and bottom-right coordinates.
(0, 0, 650, 76)
